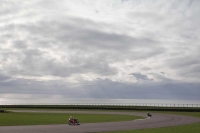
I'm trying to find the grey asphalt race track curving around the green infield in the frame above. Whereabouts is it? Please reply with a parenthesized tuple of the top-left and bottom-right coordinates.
(0, 111, 200, 133)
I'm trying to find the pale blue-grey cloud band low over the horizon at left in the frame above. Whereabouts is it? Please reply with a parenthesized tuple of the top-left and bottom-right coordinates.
(0, 78, 88, 98)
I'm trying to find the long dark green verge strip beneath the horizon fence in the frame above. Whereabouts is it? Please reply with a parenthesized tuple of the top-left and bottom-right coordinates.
(0, 105, 200, 112)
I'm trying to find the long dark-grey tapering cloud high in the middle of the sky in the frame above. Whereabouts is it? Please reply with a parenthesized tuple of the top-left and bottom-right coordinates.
(13, 17, 158, 50)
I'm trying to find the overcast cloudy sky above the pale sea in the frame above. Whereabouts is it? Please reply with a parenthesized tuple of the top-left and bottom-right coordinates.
(0, 0, 200, 103)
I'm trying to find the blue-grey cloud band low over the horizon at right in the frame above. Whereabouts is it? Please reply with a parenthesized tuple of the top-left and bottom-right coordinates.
(82, 80, 200, 100)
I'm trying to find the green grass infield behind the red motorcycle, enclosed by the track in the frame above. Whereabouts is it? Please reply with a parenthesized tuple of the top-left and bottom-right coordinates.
(0, 112, 143, 126)
